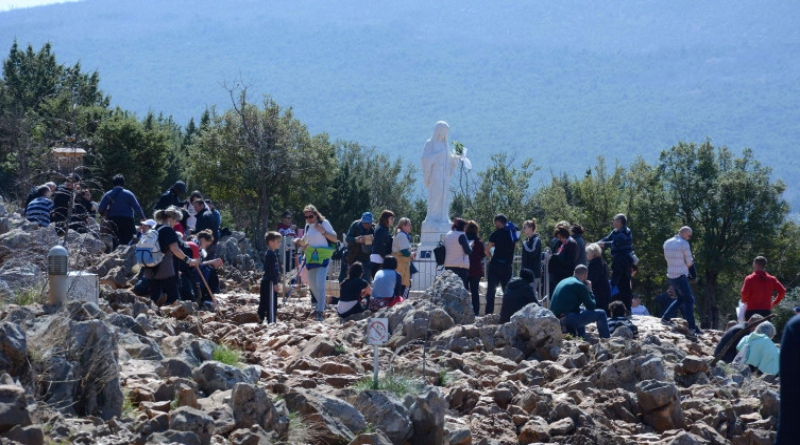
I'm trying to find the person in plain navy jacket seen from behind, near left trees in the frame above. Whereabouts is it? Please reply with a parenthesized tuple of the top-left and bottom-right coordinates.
(97, 174, 147, 246)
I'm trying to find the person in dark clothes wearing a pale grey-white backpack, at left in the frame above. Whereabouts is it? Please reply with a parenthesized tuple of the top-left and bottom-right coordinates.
(136, 206, 198, 306)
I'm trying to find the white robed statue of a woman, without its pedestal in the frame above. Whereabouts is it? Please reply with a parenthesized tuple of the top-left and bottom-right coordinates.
(422, 121, 461, 231)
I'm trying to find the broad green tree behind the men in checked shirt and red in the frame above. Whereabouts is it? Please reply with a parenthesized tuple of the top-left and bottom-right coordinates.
(660, 141, 789, 328)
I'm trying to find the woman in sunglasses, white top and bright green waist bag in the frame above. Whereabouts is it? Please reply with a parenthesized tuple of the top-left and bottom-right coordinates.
(302, 204, 336, 321)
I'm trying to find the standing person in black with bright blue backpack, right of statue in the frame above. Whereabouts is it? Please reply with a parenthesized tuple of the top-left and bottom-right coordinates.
(485, 213, 519, 315)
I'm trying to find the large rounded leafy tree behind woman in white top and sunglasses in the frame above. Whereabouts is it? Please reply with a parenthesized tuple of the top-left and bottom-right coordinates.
(189, 88, 335, 247)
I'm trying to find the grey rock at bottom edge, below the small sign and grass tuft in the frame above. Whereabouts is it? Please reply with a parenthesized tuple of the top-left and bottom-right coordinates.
(355, 390, 416, 445)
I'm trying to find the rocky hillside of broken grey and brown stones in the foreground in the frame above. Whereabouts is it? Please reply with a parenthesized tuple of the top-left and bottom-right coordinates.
(0, 206, 778, 445)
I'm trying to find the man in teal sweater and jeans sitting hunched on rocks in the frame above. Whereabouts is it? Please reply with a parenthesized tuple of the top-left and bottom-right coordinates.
(550, 264, 611, 339)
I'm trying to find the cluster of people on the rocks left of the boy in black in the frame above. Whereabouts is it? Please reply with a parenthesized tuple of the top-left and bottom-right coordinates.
(24, 173, 222, 306)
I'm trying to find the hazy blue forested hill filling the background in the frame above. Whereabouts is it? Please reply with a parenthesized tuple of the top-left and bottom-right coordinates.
(0, 0, 800, 206)
